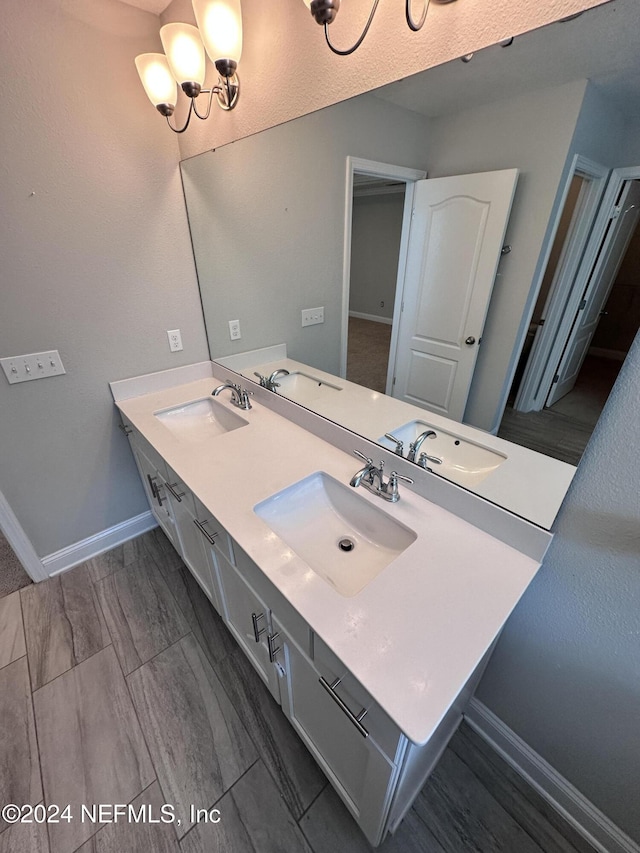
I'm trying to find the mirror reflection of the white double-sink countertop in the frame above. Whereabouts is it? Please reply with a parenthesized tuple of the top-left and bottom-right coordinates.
(221, 347, 576, 530)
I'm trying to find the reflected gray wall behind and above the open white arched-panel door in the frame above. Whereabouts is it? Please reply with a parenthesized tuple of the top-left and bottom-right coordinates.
(429, 81, 586, 430)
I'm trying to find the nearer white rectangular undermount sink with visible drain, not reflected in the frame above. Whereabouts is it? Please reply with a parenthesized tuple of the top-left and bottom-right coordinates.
(254, 472, 416, 597)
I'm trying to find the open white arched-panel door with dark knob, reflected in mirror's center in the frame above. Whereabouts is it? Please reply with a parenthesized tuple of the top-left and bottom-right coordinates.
(393, 169, 518, 421)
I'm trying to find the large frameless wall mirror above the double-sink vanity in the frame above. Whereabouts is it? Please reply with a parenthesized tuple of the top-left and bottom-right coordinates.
(181, 0, 640, 526)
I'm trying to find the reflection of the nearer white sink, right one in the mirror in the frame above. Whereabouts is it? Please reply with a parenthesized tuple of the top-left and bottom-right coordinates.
(378, 420, 507, 486)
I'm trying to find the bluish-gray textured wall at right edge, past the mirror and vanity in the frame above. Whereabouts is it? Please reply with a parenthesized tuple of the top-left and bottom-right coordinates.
(478, 328, 640, 842)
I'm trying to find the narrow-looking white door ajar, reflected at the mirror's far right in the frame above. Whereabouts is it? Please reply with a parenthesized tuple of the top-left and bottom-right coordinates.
(545, 181, 640, 406)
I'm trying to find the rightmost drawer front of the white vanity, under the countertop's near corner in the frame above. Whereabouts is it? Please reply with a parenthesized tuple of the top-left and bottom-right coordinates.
(313, 634, 404, 761)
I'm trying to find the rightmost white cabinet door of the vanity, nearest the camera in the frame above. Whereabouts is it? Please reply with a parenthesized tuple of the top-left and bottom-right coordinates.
(274, 620, 398, 845)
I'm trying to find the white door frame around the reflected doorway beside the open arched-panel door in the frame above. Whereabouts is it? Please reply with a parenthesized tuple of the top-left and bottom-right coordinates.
(340, 157, 427, 376)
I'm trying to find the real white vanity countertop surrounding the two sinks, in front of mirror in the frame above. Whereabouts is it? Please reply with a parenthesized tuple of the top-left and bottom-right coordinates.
(112, 365, 539, 743)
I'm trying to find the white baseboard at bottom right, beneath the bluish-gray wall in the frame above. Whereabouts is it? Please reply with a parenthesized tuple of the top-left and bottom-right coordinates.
(464, 699, 640, 853)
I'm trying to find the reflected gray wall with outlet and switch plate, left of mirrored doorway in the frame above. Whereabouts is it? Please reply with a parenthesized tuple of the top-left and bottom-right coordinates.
(183, 95, 429, 374)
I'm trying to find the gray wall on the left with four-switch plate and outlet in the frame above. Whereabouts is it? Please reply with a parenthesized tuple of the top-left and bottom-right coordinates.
(0, 0, 207, 556)
